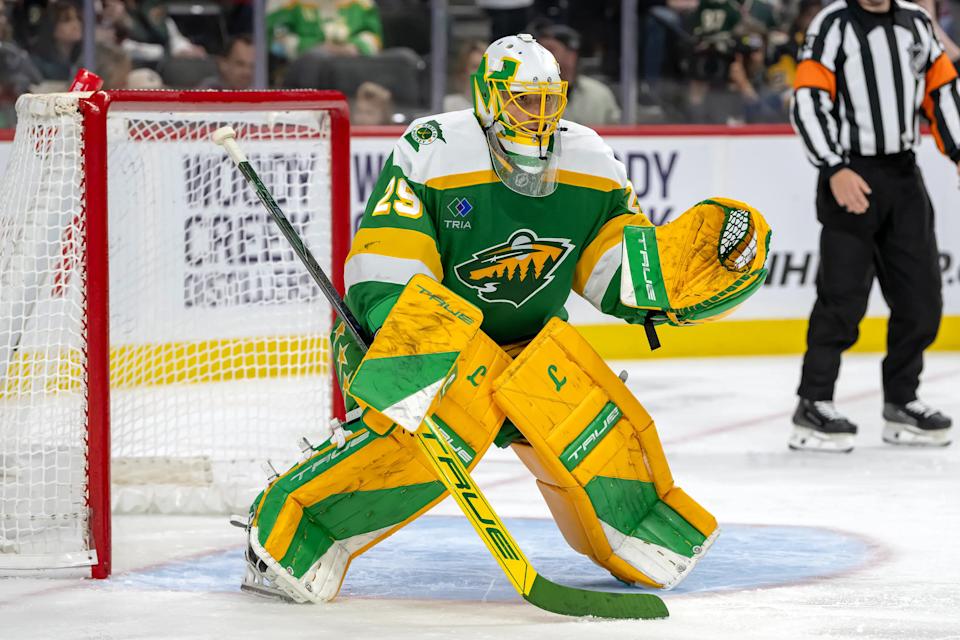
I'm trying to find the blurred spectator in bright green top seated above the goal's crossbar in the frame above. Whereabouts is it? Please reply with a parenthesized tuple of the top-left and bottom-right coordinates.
(267, 0, 383, 60)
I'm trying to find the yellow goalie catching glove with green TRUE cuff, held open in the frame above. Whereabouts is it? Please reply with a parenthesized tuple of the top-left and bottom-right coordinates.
(620, 198, 771, 326)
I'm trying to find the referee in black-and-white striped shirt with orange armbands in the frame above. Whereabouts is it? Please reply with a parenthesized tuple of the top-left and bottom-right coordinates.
(789, 0, 960, 452)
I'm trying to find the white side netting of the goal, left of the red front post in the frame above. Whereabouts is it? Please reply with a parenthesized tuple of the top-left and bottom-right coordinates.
(0, 99, 90, 564)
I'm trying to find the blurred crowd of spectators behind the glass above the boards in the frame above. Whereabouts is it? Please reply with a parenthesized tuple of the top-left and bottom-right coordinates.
(0, 0, 960, 128)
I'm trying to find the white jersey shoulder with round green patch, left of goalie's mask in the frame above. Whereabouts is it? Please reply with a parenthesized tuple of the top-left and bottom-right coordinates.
(393, 109, 492, 184)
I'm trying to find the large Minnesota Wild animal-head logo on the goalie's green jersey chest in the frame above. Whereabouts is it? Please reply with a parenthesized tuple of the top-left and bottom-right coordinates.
(454, 229, 574, 307)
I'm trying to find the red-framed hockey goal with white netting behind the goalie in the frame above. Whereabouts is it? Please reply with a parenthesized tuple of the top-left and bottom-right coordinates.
(0, 91, 350, 578)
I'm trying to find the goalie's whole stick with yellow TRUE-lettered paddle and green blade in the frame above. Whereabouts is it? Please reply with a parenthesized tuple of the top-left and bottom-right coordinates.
(212, 127, 669, 618)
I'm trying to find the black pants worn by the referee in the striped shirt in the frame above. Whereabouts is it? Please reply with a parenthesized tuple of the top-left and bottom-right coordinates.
(797, 152, 943, 404)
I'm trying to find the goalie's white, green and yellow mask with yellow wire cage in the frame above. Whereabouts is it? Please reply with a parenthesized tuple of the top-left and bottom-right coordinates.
(472, 33, 567, 197)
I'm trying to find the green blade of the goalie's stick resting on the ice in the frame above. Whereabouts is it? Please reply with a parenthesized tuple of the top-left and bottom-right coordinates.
(523, 574, 670, 620)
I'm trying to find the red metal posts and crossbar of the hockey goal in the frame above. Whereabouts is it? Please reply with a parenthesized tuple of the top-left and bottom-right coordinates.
(79, 89, 351, 579)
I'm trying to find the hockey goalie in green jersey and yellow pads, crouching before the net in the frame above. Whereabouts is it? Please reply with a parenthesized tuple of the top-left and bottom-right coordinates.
(243, 34, 770, 602)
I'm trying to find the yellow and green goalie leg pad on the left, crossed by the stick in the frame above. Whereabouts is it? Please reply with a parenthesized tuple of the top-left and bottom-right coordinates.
(249, 333, 510, 602)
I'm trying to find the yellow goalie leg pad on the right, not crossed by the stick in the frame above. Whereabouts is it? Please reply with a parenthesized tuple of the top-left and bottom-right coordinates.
(494, 319, 718, 588)
